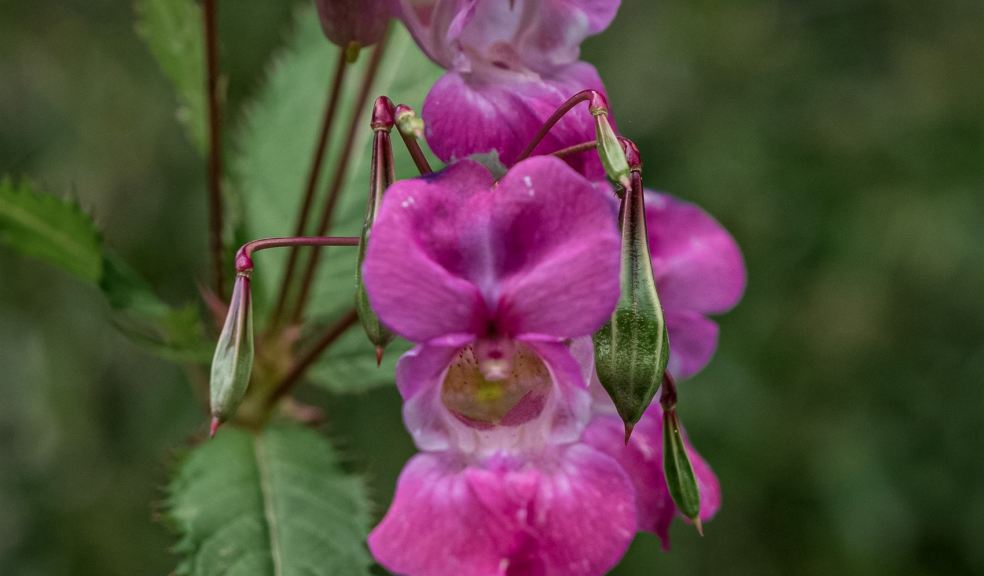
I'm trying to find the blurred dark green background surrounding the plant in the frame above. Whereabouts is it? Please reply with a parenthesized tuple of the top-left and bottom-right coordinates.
(0, 0, 984, 575)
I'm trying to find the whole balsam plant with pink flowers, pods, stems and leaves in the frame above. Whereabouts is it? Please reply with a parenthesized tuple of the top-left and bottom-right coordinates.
(0, 0, 745, 576)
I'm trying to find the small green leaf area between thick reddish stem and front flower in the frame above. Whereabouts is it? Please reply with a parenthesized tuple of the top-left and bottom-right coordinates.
(308, 326, 410, 394)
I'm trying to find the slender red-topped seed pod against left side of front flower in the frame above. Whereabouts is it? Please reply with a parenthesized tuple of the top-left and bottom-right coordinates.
(355, 96, 395, 363)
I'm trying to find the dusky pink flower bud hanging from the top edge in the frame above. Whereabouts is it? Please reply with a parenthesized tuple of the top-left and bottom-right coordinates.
(315, 0, 392, 57)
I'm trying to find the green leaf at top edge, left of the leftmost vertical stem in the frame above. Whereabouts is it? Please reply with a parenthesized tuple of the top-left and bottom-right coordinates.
(136, 0, 205, 152)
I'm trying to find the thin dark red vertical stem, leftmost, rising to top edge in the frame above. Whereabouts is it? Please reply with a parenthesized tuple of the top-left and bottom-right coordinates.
(204, 0, 225, 299)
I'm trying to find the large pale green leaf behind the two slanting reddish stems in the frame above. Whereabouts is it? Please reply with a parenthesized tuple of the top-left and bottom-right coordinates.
(231, 5, 441, 321)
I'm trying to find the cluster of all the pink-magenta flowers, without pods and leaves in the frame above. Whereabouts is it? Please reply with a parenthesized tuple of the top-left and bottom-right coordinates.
(361, 0, 745, 575)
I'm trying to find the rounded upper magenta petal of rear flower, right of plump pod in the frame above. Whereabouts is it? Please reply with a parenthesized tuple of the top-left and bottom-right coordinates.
(646, 192, 746, 316)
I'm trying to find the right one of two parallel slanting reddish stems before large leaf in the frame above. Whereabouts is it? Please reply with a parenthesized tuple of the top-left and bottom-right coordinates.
(292, 36, 386, 324)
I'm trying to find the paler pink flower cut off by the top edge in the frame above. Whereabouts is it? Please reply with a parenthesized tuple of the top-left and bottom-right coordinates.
(400, 0, 620, 169)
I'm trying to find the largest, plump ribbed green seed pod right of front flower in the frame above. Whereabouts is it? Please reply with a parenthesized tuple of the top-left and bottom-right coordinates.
(593, 171, 670, 432)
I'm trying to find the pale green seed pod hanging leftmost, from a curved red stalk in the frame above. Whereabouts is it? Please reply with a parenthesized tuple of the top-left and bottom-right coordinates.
(210, 270, 253, 435)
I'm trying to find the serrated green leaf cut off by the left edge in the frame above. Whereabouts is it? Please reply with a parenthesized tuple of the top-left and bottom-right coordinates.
(0, 179, 103, 283)
